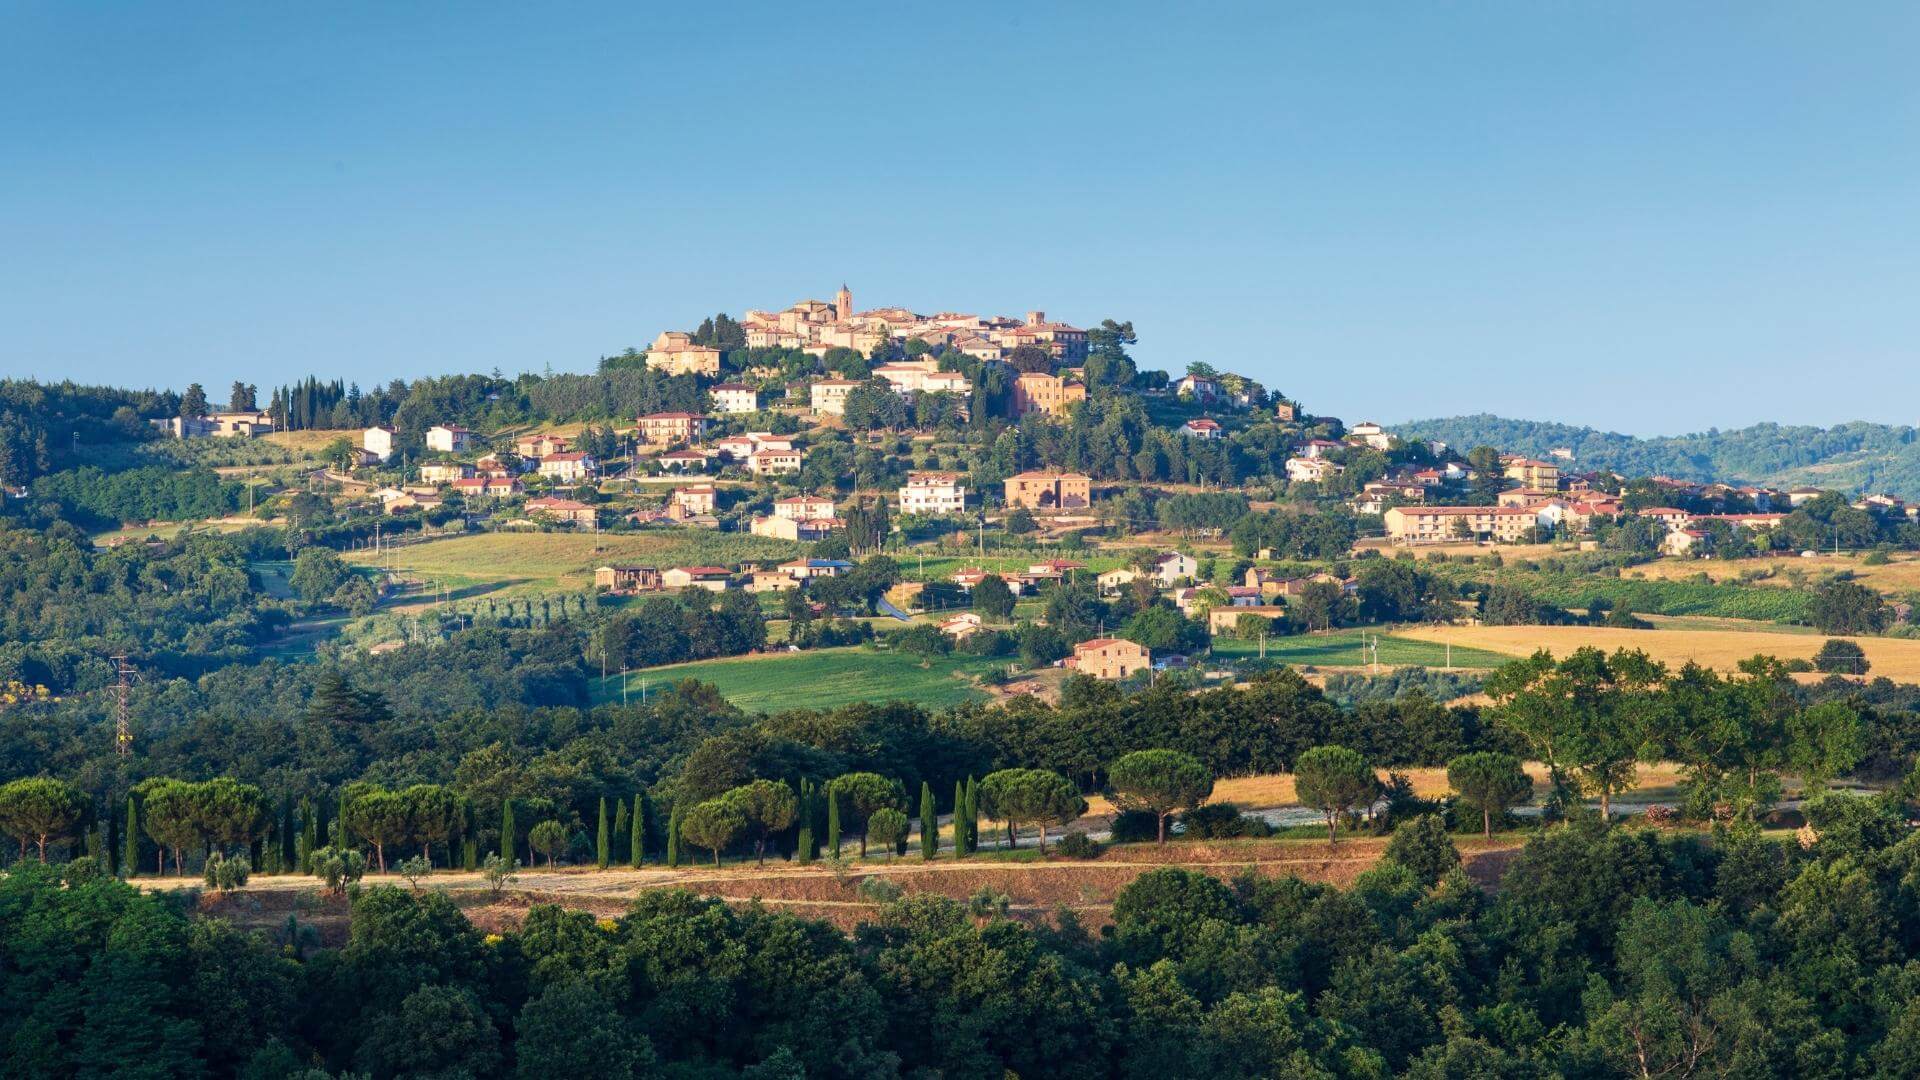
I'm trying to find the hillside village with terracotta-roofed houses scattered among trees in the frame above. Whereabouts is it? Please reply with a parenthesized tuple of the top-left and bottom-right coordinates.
(63, 286, 1920, 690)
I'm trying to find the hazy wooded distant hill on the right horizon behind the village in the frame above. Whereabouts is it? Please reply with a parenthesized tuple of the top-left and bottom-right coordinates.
(1394, 413, 1920, 500)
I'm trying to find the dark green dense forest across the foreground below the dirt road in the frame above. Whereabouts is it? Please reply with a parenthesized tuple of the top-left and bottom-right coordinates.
(18, 798, 1920, 1080)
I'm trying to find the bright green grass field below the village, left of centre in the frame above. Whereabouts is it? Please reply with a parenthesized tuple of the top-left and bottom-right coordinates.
(593, 646, 1006, 713)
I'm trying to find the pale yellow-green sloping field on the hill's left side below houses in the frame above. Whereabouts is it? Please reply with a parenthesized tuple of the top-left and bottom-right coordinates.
(344, 528, 801, 592)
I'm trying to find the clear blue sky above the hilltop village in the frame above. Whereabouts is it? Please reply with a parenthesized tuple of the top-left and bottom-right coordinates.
(0, 0, 1920, 434)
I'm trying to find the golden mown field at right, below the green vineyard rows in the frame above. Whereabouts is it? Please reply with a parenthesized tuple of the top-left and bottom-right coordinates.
(1400, 626, 1920, 682)
